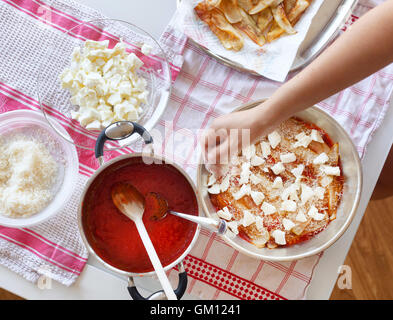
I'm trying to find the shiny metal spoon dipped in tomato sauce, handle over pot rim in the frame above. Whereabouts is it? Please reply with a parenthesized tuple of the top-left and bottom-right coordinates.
(146, 192, 227, 234)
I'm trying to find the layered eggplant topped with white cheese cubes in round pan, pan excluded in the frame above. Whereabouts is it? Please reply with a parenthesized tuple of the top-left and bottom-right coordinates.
(206, 118, 344, 248)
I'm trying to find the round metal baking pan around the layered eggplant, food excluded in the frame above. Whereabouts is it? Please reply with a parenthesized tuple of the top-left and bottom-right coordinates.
(197, 101, 363, 261)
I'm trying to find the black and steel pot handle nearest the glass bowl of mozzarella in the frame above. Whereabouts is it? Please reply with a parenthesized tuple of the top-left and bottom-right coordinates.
(95, 121, 153, 164)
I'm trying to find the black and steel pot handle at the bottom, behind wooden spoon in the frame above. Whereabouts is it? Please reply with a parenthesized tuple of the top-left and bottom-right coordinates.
(127, 262, 188, 300)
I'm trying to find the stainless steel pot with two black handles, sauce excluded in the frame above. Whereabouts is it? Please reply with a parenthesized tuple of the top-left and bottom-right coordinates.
(78, 121, 201, 300)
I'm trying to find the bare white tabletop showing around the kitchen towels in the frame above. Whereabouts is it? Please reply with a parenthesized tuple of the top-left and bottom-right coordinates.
(0, 0, 393, 299)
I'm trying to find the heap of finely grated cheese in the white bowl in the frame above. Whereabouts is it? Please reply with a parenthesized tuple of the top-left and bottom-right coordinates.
(0, 135, 58, 217)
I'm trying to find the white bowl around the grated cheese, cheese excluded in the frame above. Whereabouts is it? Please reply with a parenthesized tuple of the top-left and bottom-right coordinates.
(0, 110, 79, 228)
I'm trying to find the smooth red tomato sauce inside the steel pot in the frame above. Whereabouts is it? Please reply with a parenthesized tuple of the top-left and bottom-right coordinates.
(82, 158, 198, 273)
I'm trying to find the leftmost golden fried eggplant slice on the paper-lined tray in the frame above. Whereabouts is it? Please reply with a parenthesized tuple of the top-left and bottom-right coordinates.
(194, 2, 243, 51)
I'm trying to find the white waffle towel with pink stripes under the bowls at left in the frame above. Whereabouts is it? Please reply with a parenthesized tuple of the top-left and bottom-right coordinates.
(0, 0, 186, 285)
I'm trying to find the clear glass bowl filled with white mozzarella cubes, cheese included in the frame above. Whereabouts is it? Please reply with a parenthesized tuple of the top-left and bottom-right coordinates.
(37, 19, 172, 150)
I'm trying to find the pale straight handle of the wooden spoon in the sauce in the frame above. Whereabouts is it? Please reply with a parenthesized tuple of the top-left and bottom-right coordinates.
(134, 218, 177, 300)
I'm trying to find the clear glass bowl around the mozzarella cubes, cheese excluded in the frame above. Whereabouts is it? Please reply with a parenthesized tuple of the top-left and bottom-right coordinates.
(37, 19, 172, 151)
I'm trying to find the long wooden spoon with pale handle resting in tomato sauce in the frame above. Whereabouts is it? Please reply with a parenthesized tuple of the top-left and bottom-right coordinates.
(112, 182, 177, 300)
